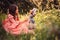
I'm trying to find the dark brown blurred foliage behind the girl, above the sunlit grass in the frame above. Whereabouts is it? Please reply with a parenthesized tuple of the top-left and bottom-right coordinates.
(0, 0, 60, 14)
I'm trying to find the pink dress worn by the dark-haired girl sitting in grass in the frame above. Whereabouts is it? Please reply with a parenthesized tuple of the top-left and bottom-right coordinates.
(2, 14, 29, 35)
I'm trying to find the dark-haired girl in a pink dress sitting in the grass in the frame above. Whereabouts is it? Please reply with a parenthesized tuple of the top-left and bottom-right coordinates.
(2, 4, 29, 35)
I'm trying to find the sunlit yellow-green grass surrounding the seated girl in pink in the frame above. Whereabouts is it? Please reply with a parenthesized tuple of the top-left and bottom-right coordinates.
(0, 9, 60, 40)
